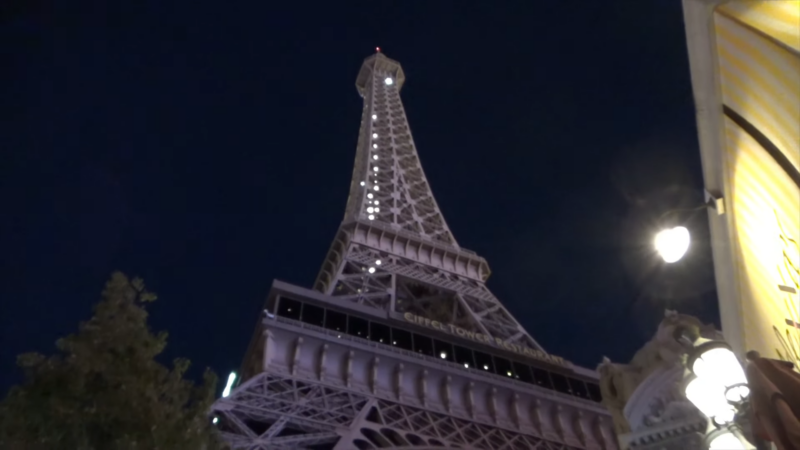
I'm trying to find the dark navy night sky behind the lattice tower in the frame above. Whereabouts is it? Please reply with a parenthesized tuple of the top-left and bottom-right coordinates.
(0, 0, 719, 395)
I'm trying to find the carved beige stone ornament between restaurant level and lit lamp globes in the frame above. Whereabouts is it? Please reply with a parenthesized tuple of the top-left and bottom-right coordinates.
(597, 310, 721, 435)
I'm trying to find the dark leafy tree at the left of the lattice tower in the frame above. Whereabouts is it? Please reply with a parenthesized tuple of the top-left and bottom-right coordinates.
(0, 272, 225, 450)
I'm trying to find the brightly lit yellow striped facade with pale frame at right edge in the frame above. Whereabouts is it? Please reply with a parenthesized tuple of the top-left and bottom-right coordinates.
(683, 0, 800, 366)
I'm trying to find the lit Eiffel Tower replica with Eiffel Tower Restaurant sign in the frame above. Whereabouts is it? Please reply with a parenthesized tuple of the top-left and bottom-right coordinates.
(211, 50, 618, 450)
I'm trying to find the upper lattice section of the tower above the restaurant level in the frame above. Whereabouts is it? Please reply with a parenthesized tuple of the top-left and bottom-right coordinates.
(314, 52, 541, 350)
